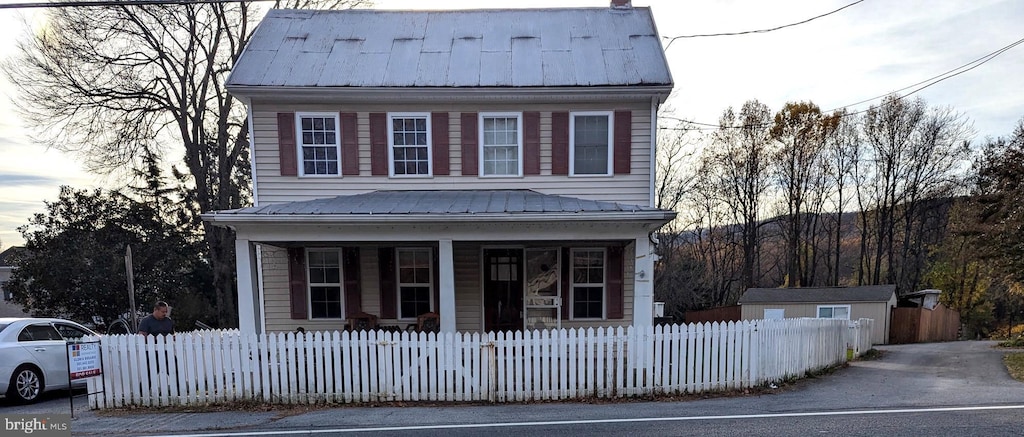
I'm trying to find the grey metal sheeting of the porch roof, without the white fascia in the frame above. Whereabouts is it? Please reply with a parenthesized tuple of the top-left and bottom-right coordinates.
(215, 189, 675, 216)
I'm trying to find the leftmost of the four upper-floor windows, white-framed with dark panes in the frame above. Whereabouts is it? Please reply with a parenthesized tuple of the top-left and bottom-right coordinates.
(295, 113, 341, 176)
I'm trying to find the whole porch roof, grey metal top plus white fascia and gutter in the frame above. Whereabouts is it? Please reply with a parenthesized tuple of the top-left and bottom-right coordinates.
(203, 189, 676, 225)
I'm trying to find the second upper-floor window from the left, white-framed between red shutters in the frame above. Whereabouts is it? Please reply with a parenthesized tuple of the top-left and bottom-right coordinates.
(388, 114, 431, 176)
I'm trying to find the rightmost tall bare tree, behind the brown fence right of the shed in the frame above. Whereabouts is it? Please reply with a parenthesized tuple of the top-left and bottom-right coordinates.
(858, 95, 971, 288)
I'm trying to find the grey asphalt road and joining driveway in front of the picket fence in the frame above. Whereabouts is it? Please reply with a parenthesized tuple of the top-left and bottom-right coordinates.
(0, 342, 1024, 436)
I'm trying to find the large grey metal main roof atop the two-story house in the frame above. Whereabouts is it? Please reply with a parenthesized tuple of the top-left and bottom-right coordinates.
(227, 7, 672, 87)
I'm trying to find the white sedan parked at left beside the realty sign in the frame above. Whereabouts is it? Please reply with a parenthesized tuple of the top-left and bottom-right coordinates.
(0, 317, 97, 403)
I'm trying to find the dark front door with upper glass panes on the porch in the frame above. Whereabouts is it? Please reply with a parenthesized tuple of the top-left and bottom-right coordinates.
(483, 249, 522, 332)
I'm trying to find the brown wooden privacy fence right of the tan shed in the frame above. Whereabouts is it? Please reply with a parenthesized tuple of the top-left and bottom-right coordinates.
(889, 304, 959, 344)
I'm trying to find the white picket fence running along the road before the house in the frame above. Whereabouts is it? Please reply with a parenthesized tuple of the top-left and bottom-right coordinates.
(89, 319, 870, 408)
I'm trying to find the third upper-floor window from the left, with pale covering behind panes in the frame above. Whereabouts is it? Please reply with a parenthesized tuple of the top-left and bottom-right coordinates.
(480, 113, 522, 176)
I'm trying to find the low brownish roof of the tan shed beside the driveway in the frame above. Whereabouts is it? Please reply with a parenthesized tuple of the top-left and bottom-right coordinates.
(739, 285, 896, 304)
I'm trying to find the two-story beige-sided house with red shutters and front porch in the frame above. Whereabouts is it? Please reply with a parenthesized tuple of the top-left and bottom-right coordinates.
(203, 0, 675, 333)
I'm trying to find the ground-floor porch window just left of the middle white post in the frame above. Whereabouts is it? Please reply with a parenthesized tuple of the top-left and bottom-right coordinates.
(397, 248, 434, 318)
